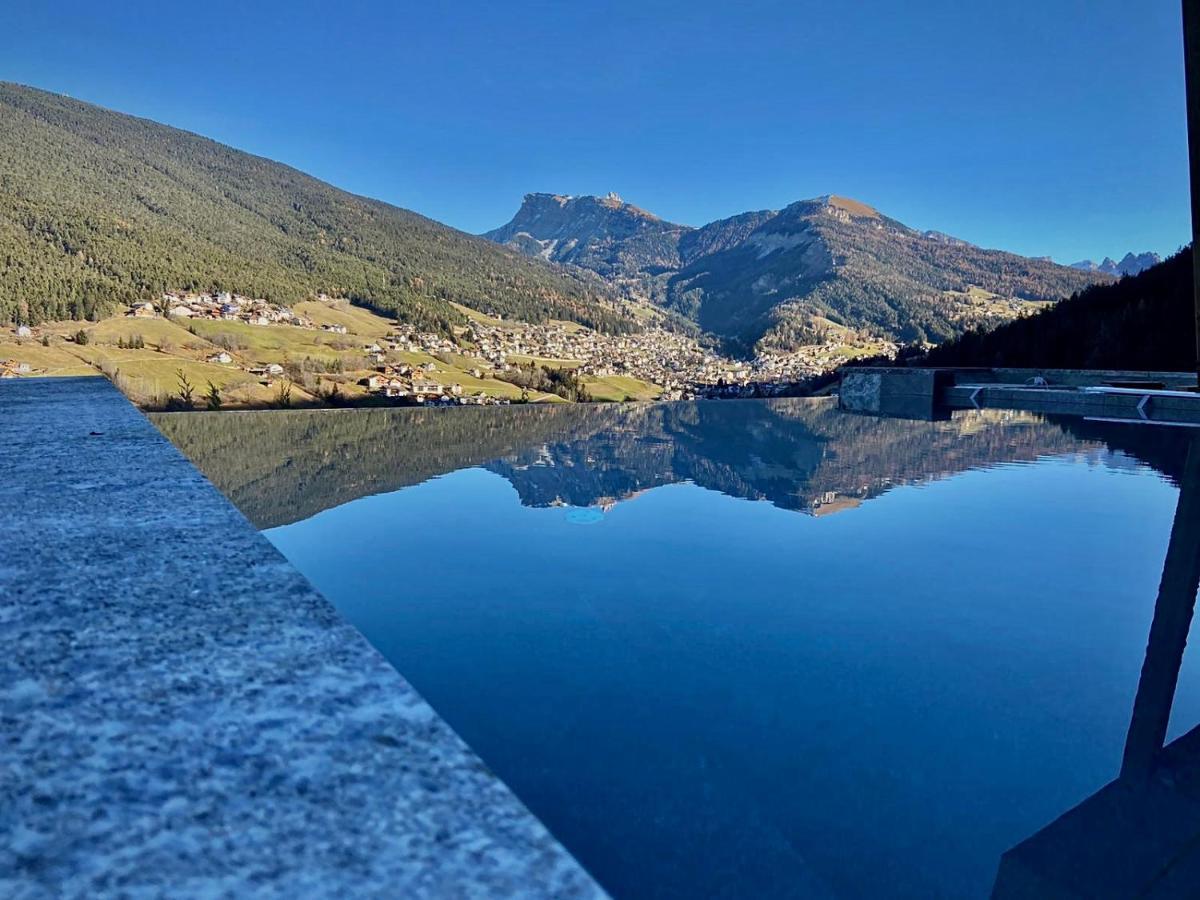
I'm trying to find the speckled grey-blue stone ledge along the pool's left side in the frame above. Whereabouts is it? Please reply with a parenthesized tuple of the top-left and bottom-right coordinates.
(0, 378, 602, 898)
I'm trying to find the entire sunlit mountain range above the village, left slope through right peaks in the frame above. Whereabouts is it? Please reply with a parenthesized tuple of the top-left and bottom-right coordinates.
(0, 83, 1112, 354)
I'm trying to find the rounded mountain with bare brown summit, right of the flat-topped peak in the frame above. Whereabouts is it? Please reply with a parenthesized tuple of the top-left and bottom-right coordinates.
(667, 197, 1108, 350)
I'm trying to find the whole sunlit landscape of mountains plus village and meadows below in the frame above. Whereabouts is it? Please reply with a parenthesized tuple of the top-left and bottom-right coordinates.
(0, 83, 1132, 409)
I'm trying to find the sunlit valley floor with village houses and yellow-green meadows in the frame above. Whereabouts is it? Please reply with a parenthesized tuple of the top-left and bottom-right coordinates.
(0, 292, 895, 409)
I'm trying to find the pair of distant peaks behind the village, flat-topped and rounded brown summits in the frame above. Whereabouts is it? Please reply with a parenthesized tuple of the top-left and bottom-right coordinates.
(484, 193, 1111, 350)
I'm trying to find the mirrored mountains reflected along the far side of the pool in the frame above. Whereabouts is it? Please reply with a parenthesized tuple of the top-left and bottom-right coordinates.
(151, 400, 1182, 528)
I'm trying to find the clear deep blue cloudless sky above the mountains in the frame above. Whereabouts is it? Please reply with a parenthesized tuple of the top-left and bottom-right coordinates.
(0, 0, 1189, 262)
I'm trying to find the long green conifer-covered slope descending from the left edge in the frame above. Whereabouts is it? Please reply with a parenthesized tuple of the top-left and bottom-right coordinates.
(0, 83, 632, 331)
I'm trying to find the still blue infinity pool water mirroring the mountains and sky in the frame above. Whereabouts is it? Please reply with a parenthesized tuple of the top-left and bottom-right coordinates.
(158, 401, 1200, 898)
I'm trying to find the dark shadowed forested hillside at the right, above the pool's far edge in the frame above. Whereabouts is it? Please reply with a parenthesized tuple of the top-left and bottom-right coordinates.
(917, 247, 1196, 372)
